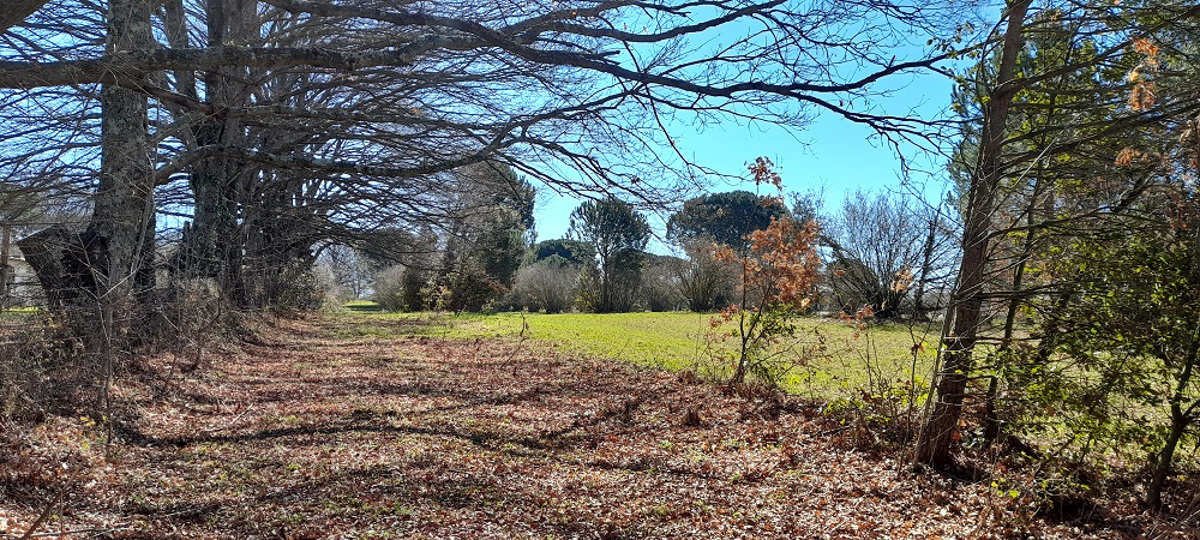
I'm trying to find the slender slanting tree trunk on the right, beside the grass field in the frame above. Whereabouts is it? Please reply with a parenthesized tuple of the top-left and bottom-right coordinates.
(914, 0, 1031, 466)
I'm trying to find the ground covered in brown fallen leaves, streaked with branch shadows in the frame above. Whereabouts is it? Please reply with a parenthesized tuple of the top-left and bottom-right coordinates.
(0, 319, 1196, 539)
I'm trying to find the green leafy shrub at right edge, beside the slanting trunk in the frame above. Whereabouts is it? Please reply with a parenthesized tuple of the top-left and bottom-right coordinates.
(1037, 194, 1200, 505)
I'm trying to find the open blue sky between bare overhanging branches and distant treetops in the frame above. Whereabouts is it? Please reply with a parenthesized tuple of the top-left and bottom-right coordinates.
(535, 68, 953, 253)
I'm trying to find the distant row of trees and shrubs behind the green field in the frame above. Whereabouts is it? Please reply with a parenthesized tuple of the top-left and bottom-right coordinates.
(340, 183, 955, 319)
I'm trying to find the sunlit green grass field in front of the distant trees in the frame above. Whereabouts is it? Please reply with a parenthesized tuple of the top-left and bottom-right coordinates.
(337, 306, 936, 398)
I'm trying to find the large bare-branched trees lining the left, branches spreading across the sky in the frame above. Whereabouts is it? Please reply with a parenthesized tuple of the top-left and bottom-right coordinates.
(0, 0, 948, 358)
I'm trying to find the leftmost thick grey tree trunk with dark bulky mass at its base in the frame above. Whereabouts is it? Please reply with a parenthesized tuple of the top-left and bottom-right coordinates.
(18, 0, 155, 321)
